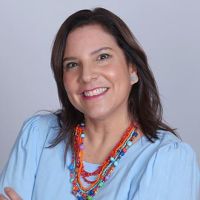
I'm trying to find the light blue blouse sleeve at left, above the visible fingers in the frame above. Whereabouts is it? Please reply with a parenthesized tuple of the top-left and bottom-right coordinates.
(0, 115, 54, 200)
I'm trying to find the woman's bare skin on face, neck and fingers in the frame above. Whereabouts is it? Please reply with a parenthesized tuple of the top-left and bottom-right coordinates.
(0, 25, 138, 200)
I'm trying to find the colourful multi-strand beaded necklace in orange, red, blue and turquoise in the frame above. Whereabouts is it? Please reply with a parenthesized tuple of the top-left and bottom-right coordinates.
(69, 124, 141, 200)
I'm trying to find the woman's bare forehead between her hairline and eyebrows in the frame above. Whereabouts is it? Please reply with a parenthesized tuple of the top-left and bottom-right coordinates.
(65, 25, 119, 54)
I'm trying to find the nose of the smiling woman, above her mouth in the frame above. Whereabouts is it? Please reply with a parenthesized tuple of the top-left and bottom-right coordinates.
(80, 63, 98, 83)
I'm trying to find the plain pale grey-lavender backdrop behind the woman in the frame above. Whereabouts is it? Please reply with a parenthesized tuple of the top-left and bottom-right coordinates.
(0, 0, 200, 171)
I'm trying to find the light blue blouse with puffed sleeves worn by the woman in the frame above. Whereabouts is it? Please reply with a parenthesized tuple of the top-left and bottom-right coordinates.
(0, 114, 200, 200)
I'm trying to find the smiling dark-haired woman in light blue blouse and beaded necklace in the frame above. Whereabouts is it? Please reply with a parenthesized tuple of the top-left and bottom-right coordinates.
(0, 8, 200, 200)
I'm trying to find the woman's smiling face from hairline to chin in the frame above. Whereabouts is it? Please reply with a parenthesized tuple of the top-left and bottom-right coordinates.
(63, 25, 135, 120)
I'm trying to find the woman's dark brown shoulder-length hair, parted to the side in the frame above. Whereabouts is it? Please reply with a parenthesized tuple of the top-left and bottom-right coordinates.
(51, 8, 176, 152)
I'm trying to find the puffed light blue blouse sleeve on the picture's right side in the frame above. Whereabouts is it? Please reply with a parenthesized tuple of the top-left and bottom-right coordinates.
(130, 142, 200, 200)
